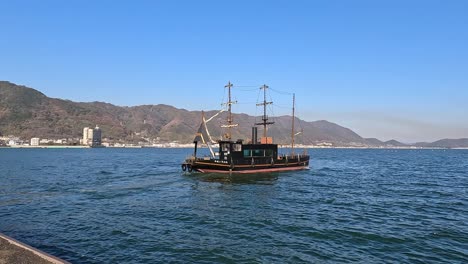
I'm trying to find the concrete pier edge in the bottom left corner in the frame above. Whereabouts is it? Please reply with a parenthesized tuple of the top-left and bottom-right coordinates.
(0, 233, 69, 264)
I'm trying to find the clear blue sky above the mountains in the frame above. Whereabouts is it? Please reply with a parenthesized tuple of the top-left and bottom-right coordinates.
(0, 0, 468, 142)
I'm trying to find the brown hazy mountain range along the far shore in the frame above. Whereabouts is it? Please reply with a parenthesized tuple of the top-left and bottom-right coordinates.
(0, 81, 468, 148)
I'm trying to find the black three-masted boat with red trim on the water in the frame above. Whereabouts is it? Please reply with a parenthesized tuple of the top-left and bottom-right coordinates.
(181, 82, 310, 174)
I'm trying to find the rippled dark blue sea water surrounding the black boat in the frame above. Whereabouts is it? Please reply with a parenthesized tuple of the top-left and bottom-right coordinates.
(0, 149, 468, 263)
